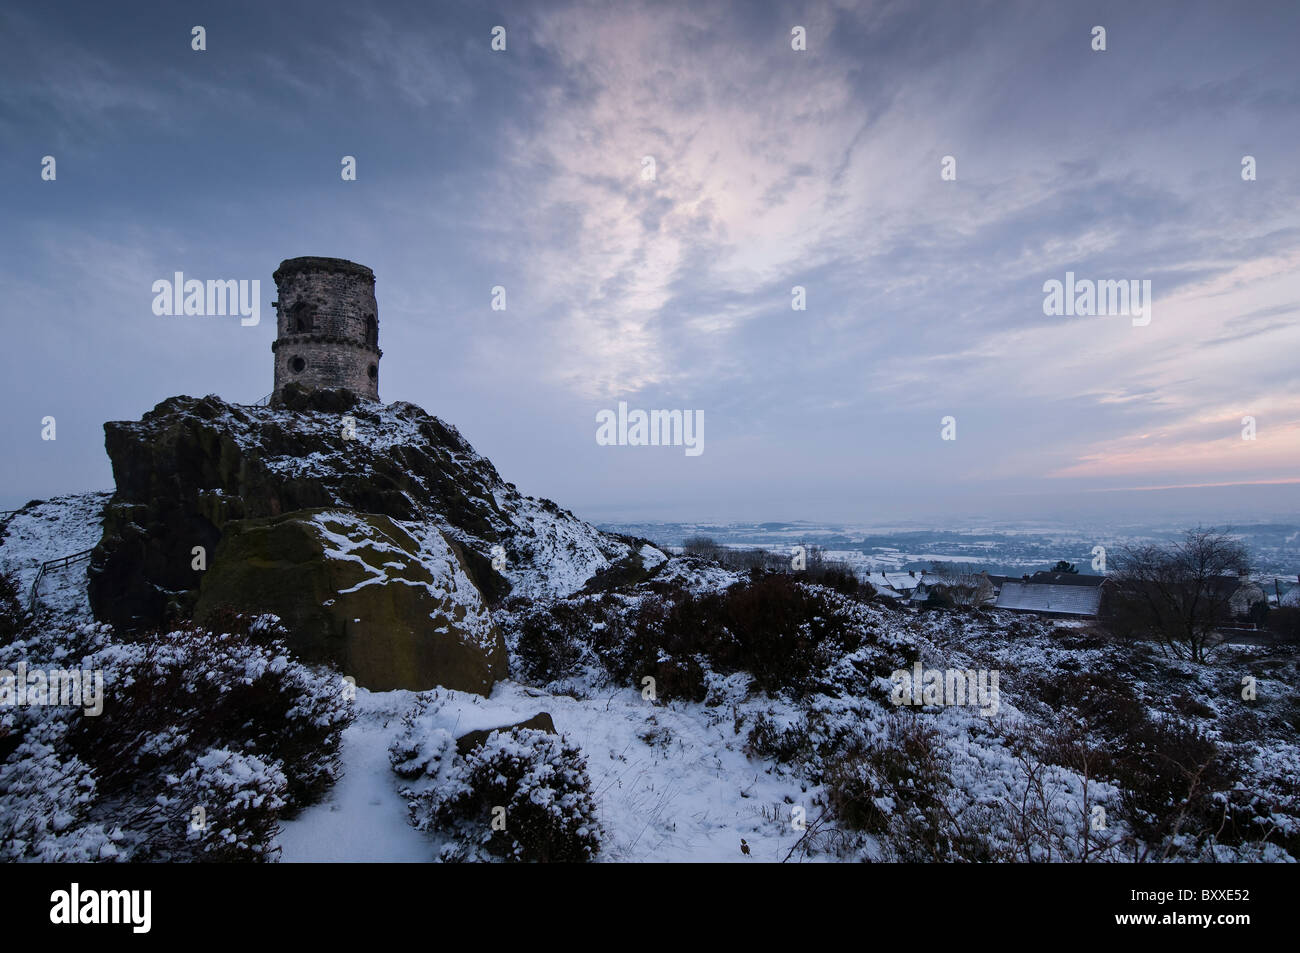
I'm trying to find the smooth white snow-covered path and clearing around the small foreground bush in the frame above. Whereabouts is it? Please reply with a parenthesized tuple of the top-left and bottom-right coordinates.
(280, 681, 811, 863)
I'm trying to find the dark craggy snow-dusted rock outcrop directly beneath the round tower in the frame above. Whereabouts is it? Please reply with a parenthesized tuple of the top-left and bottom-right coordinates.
(90, 385, 636, 628)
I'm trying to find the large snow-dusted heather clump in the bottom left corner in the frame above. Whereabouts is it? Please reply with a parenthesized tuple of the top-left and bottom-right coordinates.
(0, 618, 351, 861)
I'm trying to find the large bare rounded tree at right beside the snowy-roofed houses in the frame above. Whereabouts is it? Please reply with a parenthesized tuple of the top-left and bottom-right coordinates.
(1102, 529, 1248, 663)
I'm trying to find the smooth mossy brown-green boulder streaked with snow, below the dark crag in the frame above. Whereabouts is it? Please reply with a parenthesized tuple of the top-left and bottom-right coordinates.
(194, 510, 507, 694)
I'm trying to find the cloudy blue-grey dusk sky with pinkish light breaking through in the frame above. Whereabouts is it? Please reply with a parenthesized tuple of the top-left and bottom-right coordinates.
(0, 0, 1300, 523)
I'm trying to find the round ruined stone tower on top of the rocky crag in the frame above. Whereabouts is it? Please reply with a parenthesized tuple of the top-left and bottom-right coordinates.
(270, 257, 384, 400)
